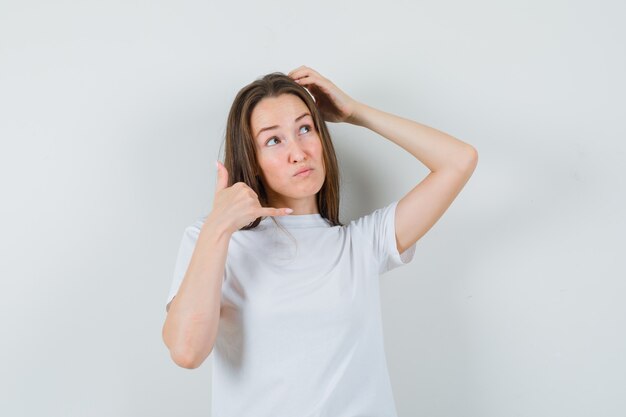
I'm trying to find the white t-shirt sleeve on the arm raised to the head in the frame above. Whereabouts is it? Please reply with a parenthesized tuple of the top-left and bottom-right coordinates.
(351, 201, 417, 274)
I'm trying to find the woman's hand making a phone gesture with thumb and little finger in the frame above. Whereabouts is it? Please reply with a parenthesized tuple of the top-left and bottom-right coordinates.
(211, 161, 291, 233)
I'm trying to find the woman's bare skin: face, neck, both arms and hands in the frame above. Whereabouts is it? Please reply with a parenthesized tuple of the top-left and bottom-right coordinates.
(163, 66, 478, 369)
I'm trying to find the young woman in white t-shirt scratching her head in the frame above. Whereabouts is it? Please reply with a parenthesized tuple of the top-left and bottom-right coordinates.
(163, 66, 477, 417)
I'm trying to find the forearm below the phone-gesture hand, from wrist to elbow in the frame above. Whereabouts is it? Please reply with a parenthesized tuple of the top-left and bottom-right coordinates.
(163, 216, 231, 368)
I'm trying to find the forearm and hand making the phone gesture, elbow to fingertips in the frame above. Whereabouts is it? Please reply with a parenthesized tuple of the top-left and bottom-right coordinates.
(163, 159, 289, 369)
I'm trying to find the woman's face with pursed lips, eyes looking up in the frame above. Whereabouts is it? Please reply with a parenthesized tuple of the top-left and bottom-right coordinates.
(250, 94, 326, 214)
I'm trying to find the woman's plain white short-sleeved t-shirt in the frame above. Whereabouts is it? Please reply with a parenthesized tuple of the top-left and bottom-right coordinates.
(166, 201, 415, 417)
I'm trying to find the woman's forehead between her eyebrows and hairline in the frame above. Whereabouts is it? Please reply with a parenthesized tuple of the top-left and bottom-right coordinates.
(250, 94, 310, 127)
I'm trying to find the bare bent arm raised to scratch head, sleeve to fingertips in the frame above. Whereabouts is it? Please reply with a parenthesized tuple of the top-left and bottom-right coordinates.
(289, 66, 478, 253)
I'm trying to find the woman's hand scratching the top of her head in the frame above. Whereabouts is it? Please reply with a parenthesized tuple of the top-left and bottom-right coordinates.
(287, 66, 358, 123)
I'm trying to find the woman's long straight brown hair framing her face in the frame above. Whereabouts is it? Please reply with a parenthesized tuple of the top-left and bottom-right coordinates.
(219, 72, 343, 230)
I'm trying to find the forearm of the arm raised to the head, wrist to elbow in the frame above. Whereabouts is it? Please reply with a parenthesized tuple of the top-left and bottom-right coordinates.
(347, 103, 475, 172)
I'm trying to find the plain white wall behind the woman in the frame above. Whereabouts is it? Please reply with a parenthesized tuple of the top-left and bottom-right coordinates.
(0, 0, 626, 417)
